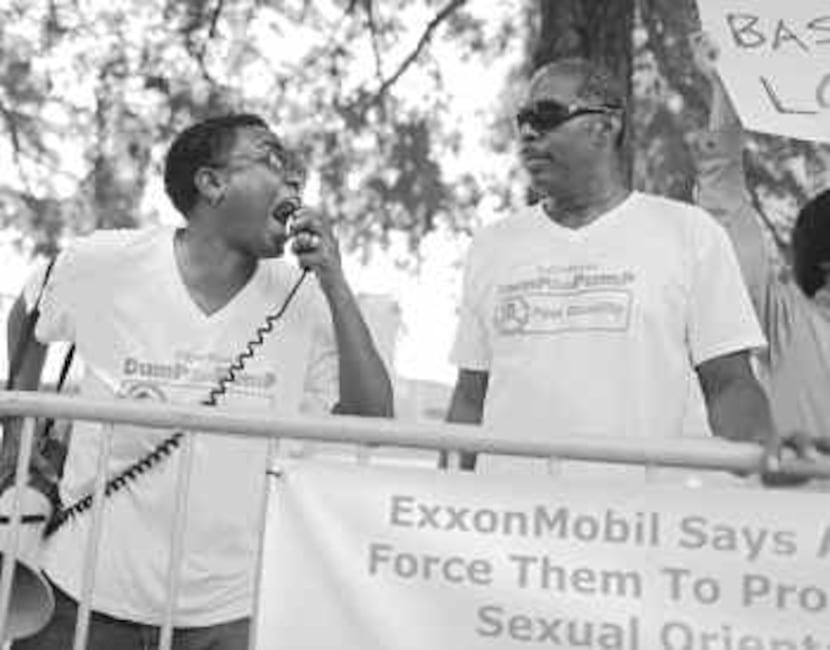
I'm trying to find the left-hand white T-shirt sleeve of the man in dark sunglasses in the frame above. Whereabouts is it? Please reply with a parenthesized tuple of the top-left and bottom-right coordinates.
(450, 238, 492, 371)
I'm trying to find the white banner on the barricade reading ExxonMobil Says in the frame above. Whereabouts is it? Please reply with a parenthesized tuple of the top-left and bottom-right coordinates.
(255, 463, 830, 650)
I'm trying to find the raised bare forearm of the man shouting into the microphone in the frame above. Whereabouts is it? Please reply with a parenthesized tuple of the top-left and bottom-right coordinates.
(321, 277, 394, 417)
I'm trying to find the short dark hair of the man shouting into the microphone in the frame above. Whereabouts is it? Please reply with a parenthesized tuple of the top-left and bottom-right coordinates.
(164, 113, 268, 217)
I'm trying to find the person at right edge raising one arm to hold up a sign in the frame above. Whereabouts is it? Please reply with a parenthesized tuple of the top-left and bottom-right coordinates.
(688, 32, 830, 486)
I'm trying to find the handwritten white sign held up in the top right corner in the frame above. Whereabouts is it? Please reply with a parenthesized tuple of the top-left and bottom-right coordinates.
(698, 0, 830, 142)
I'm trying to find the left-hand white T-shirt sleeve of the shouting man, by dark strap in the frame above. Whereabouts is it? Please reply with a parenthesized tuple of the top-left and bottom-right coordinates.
(23, 248, 78, 343)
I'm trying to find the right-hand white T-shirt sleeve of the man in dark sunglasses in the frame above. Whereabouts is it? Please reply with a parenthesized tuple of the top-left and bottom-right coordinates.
(687, 215, 766, 366)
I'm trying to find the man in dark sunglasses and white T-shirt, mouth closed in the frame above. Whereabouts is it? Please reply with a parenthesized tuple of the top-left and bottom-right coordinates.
(448, 59, 775, 478)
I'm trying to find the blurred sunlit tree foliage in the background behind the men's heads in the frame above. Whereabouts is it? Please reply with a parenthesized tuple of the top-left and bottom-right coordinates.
(0, 0, 830, 266)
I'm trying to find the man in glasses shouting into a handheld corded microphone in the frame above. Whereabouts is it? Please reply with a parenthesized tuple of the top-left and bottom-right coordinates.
(4, 114, 392, 650)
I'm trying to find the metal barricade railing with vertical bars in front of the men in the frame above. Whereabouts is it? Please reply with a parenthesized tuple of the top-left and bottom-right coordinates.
(0, 392, 830, 650)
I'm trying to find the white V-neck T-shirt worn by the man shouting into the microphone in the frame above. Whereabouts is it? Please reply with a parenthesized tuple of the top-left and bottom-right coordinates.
(28, 228, 338, 627)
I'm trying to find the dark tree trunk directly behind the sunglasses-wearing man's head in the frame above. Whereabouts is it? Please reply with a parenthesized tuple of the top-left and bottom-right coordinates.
(529, 0, 635, 183)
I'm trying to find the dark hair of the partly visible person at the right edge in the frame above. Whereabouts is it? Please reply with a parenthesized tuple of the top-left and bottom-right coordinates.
(792, 190, 830, 298)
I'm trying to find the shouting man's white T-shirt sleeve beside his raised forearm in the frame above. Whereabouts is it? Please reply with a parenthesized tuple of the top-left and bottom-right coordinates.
(300, 292, 340, 414)
